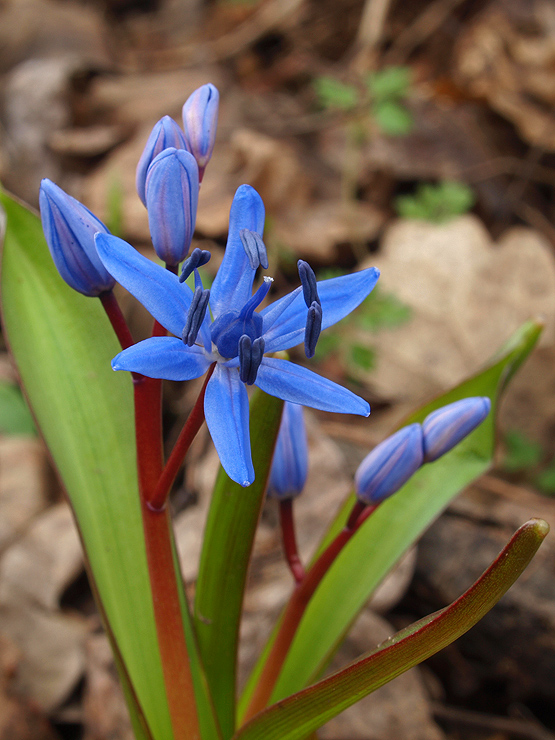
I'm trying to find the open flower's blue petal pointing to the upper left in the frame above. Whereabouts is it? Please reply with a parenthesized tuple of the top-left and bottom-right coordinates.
(95, 234, 193, 337)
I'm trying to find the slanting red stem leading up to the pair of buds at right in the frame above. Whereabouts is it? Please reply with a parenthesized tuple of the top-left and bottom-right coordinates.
(243, 501, 377, 722)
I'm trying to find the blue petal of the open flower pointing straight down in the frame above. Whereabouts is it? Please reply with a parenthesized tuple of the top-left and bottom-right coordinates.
(204, 365, 254, 486)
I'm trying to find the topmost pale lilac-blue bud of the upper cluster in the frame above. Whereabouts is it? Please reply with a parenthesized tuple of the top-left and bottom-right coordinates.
(183, 84, 220, 180)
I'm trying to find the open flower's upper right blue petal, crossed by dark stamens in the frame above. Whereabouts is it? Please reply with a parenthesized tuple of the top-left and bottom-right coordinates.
(260, 267, 380, 352)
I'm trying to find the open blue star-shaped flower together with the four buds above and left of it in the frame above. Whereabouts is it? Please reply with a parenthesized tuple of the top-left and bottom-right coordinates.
(41, 85, 379, 486)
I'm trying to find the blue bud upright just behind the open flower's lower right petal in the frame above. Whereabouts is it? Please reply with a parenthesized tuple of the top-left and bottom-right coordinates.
(268, 401, 308, 499)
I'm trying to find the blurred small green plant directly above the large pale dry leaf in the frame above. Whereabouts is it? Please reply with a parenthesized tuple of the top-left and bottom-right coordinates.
(395, 181, 475, 224)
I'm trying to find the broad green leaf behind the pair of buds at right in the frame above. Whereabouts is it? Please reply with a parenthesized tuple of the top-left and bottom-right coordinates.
(240, 322, 542, 715)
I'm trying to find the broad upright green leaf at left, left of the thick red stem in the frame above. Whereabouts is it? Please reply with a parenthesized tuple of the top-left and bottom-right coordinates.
(0, 193, 217, 740)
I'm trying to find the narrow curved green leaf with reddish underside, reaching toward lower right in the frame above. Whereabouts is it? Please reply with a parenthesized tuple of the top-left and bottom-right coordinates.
(234, 519, 549, 740)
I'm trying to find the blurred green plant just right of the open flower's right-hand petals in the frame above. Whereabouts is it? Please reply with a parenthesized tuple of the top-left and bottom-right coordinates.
(315, 280, 411, 376)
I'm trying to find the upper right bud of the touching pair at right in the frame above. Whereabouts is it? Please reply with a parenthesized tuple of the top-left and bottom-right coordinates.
(422, 396, 491, 462)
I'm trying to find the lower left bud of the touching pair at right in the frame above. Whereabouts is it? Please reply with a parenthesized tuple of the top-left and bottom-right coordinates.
(355, 424, 423, 505)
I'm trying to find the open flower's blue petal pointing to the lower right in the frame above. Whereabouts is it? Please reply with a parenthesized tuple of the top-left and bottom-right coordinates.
(255, 358, 370, 416)
